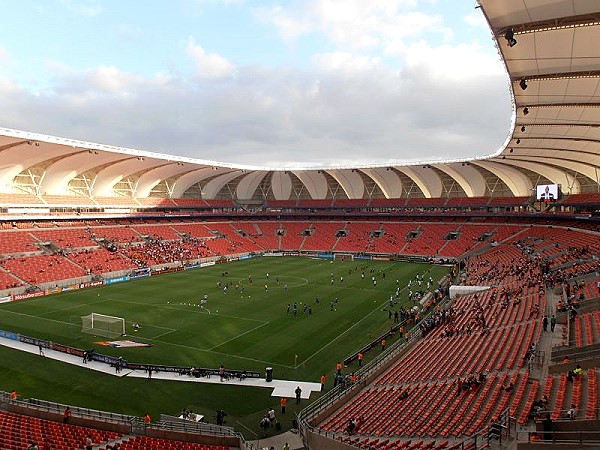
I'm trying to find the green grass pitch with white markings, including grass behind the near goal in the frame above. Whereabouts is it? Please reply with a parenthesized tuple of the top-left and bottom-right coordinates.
(0, 257, 448, 438)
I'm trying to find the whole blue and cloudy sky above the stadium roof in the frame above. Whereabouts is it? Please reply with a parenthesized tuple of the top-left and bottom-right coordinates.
(0, 0, 512, 168)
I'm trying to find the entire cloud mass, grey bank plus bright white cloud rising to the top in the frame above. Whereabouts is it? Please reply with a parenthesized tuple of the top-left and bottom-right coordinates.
(0, 0, 511, 166)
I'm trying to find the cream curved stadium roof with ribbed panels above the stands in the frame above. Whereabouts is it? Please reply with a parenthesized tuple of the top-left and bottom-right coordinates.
(0, 0, 600, 201)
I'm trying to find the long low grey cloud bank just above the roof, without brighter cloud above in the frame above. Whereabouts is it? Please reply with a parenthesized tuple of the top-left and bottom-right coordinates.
(0, 52, 510, 165)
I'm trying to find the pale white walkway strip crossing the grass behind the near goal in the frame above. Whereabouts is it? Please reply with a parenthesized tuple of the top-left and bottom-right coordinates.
(0, 337, 321, 400)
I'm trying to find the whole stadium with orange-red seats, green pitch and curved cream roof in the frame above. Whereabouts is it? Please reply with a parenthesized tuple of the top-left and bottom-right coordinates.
(0, 0, 600, 450)
